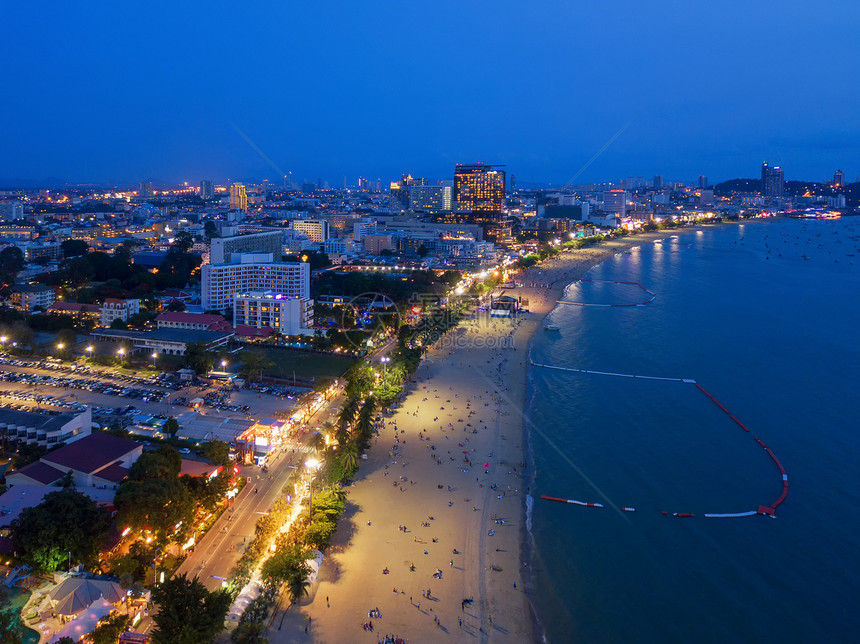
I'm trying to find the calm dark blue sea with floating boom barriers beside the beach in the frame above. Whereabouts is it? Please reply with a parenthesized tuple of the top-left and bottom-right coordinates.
(528, 217, 860, 643)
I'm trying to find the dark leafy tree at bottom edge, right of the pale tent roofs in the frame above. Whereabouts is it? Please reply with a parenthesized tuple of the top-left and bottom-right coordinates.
(152, 575, 231, 644)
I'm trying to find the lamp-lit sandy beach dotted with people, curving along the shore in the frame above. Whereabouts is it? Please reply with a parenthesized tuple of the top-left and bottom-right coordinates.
(266, 228, 724, 644)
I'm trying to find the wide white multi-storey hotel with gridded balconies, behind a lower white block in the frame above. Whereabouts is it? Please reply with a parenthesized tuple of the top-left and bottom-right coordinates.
(200, 253, 311, 311)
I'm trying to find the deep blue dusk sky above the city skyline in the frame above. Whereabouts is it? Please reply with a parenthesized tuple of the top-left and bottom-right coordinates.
(0, 0, 860, 186)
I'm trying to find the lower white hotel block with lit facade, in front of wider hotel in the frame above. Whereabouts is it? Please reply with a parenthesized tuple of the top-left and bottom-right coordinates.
(233, 291, 314, 335)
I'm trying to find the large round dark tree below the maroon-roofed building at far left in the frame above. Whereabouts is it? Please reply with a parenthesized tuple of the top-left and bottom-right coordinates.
(12, 489, 111, 573)
